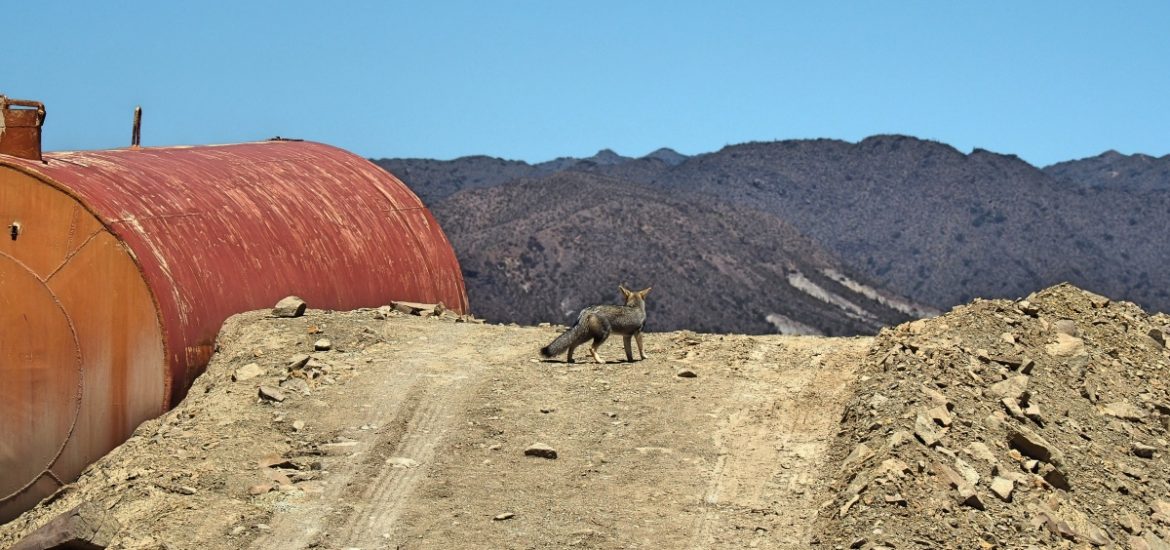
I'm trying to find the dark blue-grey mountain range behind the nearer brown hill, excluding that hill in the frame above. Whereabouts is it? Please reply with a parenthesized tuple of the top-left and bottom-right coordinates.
(379, 136, 1170, 330)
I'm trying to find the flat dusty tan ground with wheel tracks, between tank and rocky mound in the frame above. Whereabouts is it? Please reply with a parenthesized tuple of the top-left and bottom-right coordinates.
(0, 301, 870, 550)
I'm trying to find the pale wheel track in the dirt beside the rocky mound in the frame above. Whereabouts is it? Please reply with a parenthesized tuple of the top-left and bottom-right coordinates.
(691, 338, 868, 549)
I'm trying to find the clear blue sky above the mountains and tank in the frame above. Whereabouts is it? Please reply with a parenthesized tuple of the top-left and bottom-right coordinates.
(0, 0, 1170, 166)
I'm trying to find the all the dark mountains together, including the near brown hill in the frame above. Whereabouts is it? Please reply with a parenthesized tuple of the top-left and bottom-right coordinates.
(374, 136, 1170, 335)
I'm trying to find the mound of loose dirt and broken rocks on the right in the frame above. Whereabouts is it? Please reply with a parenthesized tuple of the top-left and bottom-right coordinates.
(813, 286, 1170, 549)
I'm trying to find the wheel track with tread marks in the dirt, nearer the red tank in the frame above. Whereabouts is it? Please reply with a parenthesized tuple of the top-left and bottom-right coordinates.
(252, 330, 489, 549)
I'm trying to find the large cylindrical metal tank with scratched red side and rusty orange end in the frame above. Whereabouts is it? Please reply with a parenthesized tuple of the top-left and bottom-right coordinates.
(0, 136, 468, 522)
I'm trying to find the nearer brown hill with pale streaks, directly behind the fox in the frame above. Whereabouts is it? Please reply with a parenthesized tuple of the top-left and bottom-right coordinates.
(433, 172, 926, 335)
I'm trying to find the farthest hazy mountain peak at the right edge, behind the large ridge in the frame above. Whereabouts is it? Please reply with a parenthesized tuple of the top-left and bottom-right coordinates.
(1044, 151, 1170, 191)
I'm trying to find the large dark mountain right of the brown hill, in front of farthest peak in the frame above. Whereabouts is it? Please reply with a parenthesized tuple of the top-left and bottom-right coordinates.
(622, 136, 1170, 308)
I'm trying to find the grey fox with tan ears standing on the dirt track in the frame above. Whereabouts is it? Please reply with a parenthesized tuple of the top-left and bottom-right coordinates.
(541, 286, 651, 363)
